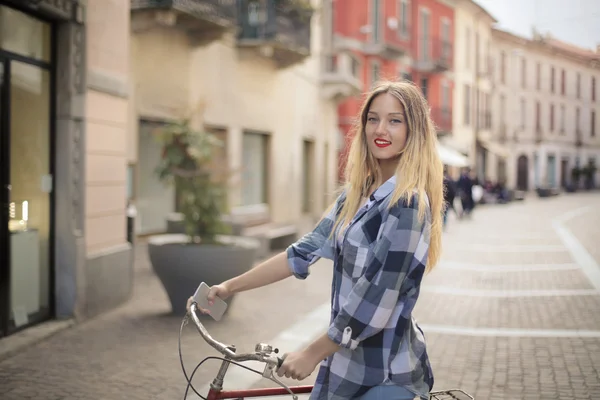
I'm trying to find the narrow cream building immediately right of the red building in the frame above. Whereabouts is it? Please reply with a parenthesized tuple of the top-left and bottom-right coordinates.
(446, 0, 503, 178)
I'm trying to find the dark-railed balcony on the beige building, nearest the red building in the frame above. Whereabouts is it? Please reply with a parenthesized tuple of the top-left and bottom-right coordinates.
(237, 0, 312, 68)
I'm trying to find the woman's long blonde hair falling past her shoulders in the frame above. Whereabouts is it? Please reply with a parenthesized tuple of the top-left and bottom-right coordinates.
(332, 81, 444, 272)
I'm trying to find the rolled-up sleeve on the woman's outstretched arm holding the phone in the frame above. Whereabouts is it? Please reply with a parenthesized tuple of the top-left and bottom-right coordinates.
(286, 193, 344, 279)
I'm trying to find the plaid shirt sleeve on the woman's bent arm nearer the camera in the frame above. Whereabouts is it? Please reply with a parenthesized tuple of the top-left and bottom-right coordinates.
(328, 205, 428, 349)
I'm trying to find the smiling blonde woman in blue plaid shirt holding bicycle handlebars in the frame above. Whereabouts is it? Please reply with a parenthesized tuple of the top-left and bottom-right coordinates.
(188, 82, 443, 400)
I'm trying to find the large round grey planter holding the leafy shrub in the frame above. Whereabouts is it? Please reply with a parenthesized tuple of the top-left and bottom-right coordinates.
(148, 234, 260, 315)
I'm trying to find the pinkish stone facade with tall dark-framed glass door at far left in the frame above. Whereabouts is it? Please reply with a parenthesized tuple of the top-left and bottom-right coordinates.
(0, 0, 132, 337)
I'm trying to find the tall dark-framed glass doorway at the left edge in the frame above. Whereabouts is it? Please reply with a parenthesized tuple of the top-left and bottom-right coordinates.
(0, 6, 53, 337)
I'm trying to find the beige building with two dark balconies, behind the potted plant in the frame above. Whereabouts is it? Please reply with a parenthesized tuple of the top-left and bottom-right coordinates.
(129, 0, 338, 244)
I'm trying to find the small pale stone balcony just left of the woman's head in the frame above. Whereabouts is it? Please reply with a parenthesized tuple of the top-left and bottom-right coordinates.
(321, 53, 363, 101)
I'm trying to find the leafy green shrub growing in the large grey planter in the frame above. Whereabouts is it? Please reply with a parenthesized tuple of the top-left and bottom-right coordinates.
(155, 118, 227, 243)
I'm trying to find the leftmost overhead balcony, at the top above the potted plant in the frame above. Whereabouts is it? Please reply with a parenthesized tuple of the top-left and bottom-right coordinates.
(131, 0, 236, 46)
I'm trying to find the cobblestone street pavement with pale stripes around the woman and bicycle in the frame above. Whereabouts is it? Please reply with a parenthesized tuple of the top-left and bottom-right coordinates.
(0, 194, 600, 400)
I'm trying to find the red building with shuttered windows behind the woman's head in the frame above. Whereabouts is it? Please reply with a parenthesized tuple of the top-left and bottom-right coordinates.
(332, 0, 454, 178)
